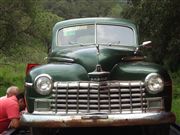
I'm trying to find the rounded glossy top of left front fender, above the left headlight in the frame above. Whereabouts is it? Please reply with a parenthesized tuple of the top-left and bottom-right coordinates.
(26, 63, 88, 83)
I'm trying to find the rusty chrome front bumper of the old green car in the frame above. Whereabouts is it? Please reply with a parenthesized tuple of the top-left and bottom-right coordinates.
(21, 112, 176, 128)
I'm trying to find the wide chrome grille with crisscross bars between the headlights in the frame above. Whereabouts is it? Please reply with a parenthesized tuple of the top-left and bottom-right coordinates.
(51, 81, 147, 114)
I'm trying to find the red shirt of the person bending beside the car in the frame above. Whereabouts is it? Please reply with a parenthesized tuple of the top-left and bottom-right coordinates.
(0, 96, 20, 133)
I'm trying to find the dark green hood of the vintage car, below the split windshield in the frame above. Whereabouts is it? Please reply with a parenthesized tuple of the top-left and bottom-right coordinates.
(48, 45, 135, 72)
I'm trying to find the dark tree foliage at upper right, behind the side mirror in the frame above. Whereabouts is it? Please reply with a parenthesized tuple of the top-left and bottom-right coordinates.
(122, 0, 180, 72)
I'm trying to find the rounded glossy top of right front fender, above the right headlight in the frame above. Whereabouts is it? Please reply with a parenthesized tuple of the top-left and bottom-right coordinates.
(110, 62, 171, 81)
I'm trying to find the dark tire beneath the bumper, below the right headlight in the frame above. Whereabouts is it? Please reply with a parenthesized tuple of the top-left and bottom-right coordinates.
(142, 124, 170, 135)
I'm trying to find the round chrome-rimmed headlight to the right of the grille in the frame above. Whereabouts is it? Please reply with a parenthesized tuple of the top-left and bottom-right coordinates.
(145, 73, 164, 94)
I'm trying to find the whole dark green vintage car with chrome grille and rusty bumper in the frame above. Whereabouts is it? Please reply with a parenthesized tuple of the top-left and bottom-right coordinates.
(21, 18, 175, 135)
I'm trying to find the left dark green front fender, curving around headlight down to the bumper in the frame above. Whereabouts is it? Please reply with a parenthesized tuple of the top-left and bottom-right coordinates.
(25, 63, 89, 112)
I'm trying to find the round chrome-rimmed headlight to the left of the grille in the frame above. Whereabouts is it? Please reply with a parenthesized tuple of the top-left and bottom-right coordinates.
(34, 74, 53, 95)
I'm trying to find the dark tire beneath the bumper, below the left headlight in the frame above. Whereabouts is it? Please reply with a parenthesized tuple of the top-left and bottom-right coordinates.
(30, 127, 59, 135)
